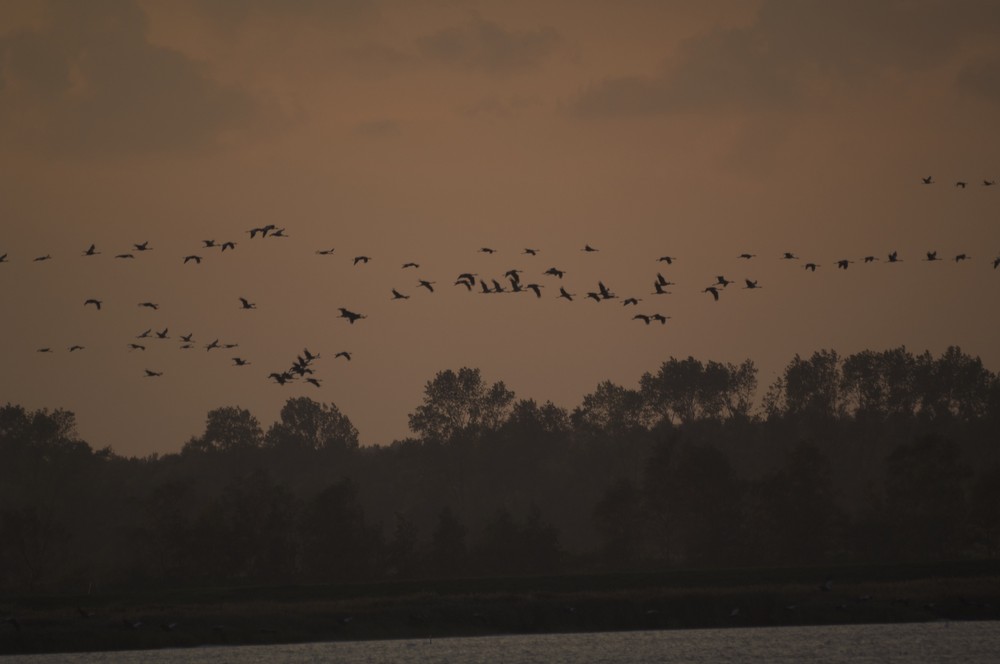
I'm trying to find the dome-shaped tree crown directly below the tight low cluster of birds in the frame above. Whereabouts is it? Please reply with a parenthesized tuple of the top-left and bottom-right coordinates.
(265, 397, 358, 450)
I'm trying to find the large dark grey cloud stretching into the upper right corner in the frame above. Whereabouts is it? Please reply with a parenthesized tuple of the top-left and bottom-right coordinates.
(571, 0, 1000, 117)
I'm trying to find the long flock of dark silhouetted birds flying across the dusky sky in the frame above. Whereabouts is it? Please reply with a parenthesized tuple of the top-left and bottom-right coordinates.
(0, 183, 1000, 388)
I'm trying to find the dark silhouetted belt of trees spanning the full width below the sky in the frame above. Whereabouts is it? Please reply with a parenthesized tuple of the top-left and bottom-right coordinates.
(0, 348, 1000, 592)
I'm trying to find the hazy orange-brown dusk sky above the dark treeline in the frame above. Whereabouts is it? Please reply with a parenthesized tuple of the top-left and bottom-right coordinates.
(0, 0, 1000, 455)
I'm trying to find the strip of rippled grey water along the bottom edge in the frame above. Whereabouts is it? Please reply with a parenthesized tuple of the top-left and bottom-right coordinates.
(4, 622, 1000, 664)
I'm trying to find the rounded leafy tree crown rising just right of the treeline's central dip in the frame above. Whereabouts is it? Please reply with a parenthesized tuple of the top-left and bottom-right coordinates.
(410, 367, 514, 442)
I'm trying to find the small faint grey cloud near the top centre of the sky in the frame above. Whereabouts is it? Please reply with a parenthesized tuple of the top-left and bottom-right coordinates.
(417, 19, 559, 74)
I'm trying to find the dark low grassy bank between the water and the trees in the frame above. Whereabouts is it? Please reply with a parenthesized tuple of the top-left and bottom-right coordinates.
(0, 562, 1000, 654)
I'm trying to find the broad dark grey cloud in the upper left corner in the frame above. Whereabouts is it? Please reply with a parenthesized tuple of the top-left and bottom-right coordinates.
(0, 0, 254, 156)
